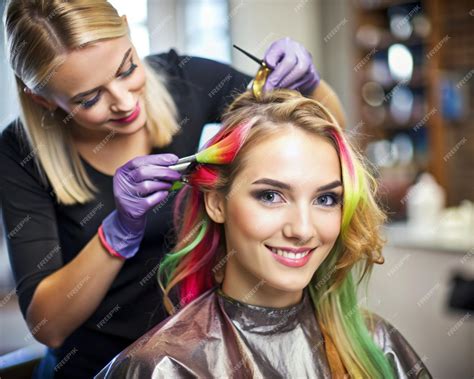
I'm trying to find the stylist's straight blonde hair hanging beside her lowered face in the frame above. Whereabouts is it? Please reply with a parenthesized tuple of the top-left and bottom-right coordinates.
(5, 0, 179, 205)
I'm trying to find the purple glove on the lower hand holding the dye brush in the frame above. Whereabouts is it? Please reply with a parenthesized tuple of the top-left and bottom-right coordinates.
(102, 154, 181, 258)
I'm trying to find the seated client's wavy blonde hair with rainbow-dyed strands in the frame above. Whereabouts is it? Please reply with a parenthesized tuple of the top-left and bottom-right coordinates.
(158, 90, 394, 378)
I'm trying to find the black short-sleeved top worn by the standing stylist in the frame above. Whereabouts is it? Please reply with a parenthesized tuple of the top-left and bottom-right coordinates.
(0, 50, 251, 378)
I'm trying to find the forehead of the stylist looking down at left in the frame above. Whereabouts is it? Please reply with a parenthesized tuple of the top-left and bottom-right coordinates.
(48, 36, 132, 96)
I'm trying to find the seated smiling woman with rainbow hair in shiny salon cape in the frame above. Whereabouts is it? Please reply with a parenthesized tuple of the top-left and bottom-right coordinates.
(97, 90, 430, 378)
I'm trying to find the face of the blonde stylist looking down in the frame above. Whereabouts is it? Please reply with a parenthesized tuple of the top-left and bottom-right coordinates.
(45, 36, 146, 135)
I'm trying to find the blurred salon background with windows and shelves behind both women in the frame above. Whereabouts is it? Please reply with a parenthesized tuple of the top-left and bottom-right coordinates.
(0, 0, 474, 379)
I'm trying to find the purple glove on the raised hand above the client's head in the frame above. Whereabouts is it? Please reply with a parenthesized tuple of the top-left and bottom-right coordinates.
(263, 37, 320, 96)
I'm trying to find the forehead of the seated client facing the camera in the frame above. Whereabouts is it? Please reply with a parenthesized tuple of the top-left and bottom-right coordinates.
(238, 127, 341, 185)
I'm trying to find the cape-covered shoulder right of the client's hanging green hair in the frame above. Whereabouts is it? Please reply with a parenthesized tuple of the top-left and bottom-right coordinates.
(363, 310, 431, 378)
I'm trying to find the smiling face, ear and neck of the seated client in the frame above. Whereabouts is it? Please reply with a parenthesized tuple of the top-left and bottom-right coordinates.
(206, 127, 343, 307)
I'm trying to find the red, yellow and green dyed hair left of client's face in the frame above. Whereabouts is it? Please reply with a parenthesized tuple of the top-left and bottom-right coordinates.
(158, 122, 252, 311)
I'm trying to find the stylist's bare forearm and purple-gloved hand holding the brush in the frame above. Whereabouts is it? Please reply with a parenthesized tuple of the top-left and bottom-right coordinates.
(27, 154, 181, 347)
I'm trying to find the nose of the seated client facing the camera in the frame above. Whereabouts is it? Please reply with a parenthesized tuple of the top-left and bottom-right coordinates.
(283, 205, 317, 246)
